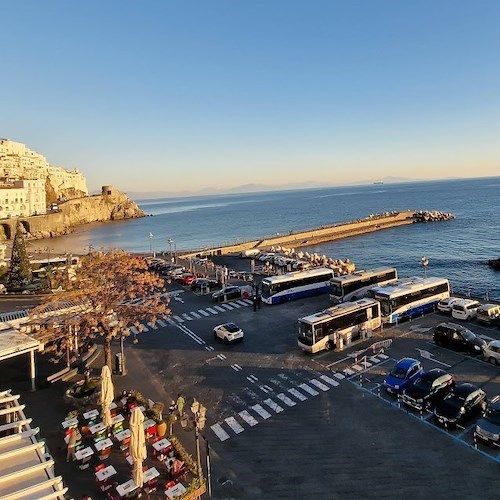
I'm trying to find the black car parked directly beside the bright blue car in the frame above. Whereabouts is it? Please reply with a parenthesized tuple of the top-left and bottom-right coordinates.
(401, 368, 455, 410)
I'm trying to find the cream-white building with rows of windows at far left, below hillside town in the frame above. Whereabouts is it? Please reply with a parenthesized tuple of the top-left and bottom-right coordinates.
(0, 179, 47, 219)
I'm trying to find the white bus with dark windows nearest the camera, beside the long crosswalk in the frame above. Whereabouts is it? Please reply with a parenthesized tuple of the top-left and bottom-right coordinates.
(298, 299, 382, 352)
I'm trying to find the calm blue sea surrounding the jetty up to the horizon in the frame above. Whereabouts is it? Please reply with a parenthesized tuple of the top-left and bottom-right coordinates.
(28, 177, 500, 300)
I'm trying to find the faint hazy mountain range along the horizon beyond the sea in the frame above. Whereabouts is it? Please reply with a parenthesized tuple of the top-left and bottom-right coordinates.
(127, 177, 422, 200)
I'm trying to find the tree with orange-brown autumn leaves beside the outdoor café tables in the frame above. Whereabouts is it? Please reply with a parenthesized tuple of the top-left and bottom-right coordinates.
(30, 250, 170, 369)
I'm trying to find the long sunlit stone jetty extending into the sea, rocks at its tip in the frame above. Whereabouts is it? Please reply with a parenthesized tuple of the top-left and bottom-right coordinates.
(180, 210, 453, 258)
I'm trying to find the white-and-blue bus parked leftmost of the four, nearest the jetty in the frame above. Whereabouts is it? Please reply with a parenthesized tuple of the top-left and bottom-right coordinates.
(261, 267, 333, 304)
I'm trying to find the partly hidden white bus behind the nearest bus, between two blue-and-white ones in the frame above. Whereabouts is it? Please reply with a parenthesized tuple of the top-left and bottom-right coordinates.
(330, 267, 398, 304)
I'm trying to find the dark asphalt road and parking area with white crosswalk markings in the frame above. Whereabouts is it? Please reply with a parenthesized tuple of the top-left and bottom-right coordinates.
(131, 285, 500, 499)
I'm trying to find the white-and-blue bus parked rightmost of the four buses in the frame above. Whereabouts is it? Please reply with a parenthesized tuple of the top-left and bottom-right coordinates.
(370, 277, 450, 323)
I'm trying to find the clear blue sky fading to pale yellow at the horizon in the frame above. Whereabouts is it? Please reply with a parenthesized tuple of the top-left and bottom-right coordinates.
(0, 0, 500, 192)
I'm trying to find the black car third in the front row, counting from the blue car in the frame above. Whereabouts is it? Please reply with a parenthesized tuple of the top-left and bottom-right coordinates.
(434, 382, 486, 425)
